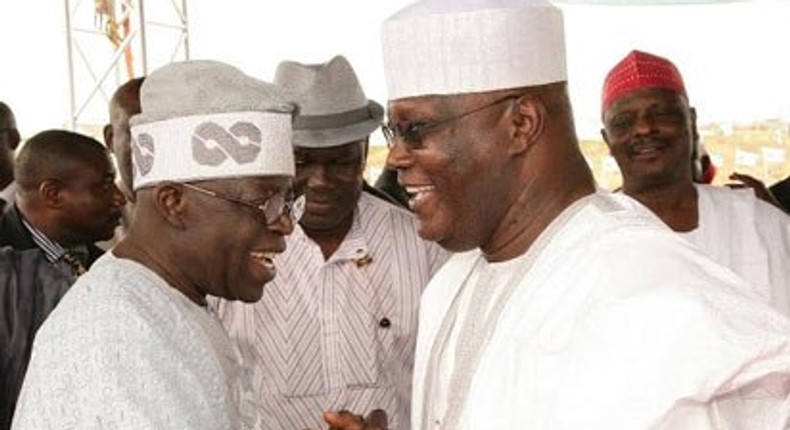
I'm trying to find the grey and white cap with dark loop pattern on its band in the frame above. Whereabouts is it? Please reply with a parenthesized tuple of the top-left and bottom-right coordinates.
(130, 61, 294, 190)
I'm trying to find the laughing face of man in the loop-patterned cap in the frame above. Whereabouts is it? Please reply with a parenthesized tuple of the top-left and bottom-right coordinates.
(183, 177, 293, 302)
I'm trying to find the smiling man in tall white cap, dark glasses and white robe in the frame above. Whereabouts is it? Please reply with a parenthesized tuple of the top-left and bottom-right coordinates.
(332, 0, 790, 430)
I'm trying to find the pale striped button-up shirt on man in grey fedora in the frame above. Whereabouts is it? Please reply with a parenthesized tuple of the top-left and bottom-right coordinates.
(218, 193, 448, 430)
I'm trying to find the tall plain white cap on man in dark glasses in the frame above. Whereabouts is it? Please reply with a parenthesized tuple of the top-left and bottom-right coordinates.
(382, 0, 567, 100)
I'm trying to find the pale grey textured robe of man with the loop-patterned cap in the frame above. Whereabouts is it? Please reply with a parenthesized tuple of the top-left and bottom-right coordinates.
(12, 252, 257, 430)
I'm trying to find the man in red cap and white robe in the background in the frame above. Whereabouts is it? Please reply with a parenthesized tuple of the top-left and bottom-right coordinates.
(601, 51, 790, 315)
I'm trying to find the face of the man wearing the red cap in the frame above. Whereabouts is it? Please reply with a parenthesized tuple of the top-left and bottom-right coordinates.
(602, 88, 696, 192)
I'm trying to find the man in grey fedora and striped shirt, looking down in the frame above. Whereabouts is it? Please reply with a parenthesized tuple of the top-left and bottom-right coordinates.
(218, 56, 446, 430)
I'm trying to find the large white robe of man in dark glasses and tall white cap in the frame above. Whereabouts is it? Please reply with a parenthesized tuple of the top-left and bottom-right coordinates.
(412, 194, 790, 430)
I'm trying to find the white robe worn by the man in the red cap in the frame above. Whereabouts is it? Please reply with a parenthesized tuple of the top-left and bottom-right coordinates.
(680, 185, 790, 316)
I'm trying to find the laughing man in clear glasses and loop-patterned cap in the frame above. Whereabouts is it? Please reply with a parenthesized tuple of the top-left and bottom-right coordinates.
(13, 61, 302, 430)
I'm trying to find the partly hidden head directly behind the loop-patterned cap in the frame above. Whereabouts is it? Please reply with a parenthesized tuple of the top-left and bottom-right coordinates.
(104, 77, 145, 199)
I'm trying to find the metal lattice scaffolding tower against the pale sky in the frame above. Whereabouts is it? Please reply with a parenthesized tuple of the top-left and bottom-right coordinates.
(65, 0, 189, 134)
